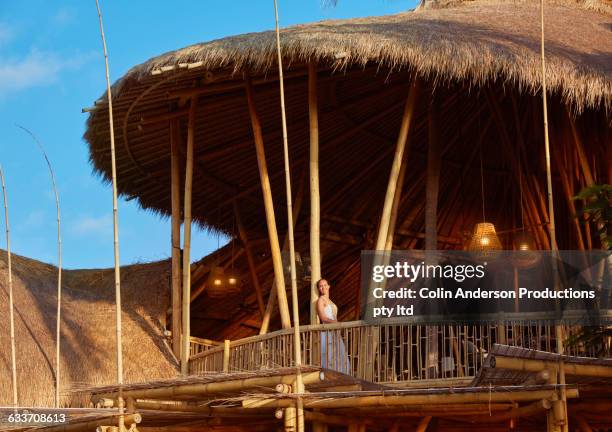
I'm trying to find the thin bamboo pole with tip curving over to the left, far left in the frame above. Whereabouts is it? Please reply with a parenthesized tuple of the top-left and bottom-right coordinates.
(17, 125, 62, 408)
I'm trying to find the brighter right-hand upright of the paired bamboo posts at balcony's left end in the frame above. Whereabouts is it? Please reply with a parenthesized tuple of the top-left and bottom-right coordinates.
(181, 98, 197, 376)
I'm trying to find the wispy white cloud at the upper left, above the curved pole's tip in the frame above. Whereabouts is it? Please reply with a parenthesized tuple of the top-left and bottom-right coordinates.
(0, 49, 94, 95)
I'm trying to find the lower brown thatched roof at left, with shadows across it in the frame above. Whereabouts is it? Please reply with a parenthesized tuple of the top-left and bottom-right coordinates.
(0, 251, 177, 406)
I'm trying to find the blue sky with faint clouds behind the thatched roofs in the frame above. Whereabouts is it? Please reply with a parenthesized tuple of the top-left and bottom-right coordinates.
(0, 0, 415, 268)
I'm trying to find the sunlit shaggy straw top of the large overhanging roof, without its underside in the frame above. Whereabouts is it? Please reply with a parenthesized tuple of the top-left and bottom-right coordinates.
(103, 0, 612, 110)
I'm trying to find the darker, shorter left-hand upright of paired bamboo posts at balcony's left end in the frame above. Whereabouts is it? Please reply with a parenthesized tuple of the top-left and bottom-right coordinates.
(170, 120, 181, 358)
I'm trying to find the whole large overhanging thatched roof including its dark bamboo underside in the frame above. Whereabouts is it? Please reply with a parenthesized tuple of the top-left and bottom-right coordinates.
(85, 0, 612, 339)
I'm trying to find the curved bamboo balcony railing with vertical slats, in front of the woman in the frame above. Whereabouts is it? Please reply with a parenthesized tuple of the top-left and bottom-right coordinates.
(189, 320, 595, 383)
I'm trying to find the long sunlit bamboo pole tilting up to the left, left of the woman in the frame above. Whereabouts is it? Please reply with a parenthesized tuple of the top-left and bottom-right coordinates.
(245, 77, 291, 328)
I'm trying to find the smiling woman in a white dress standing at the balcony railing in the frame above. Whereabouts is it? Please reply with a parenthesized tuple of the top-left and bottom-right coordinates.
(317, 279, 350, 373)
